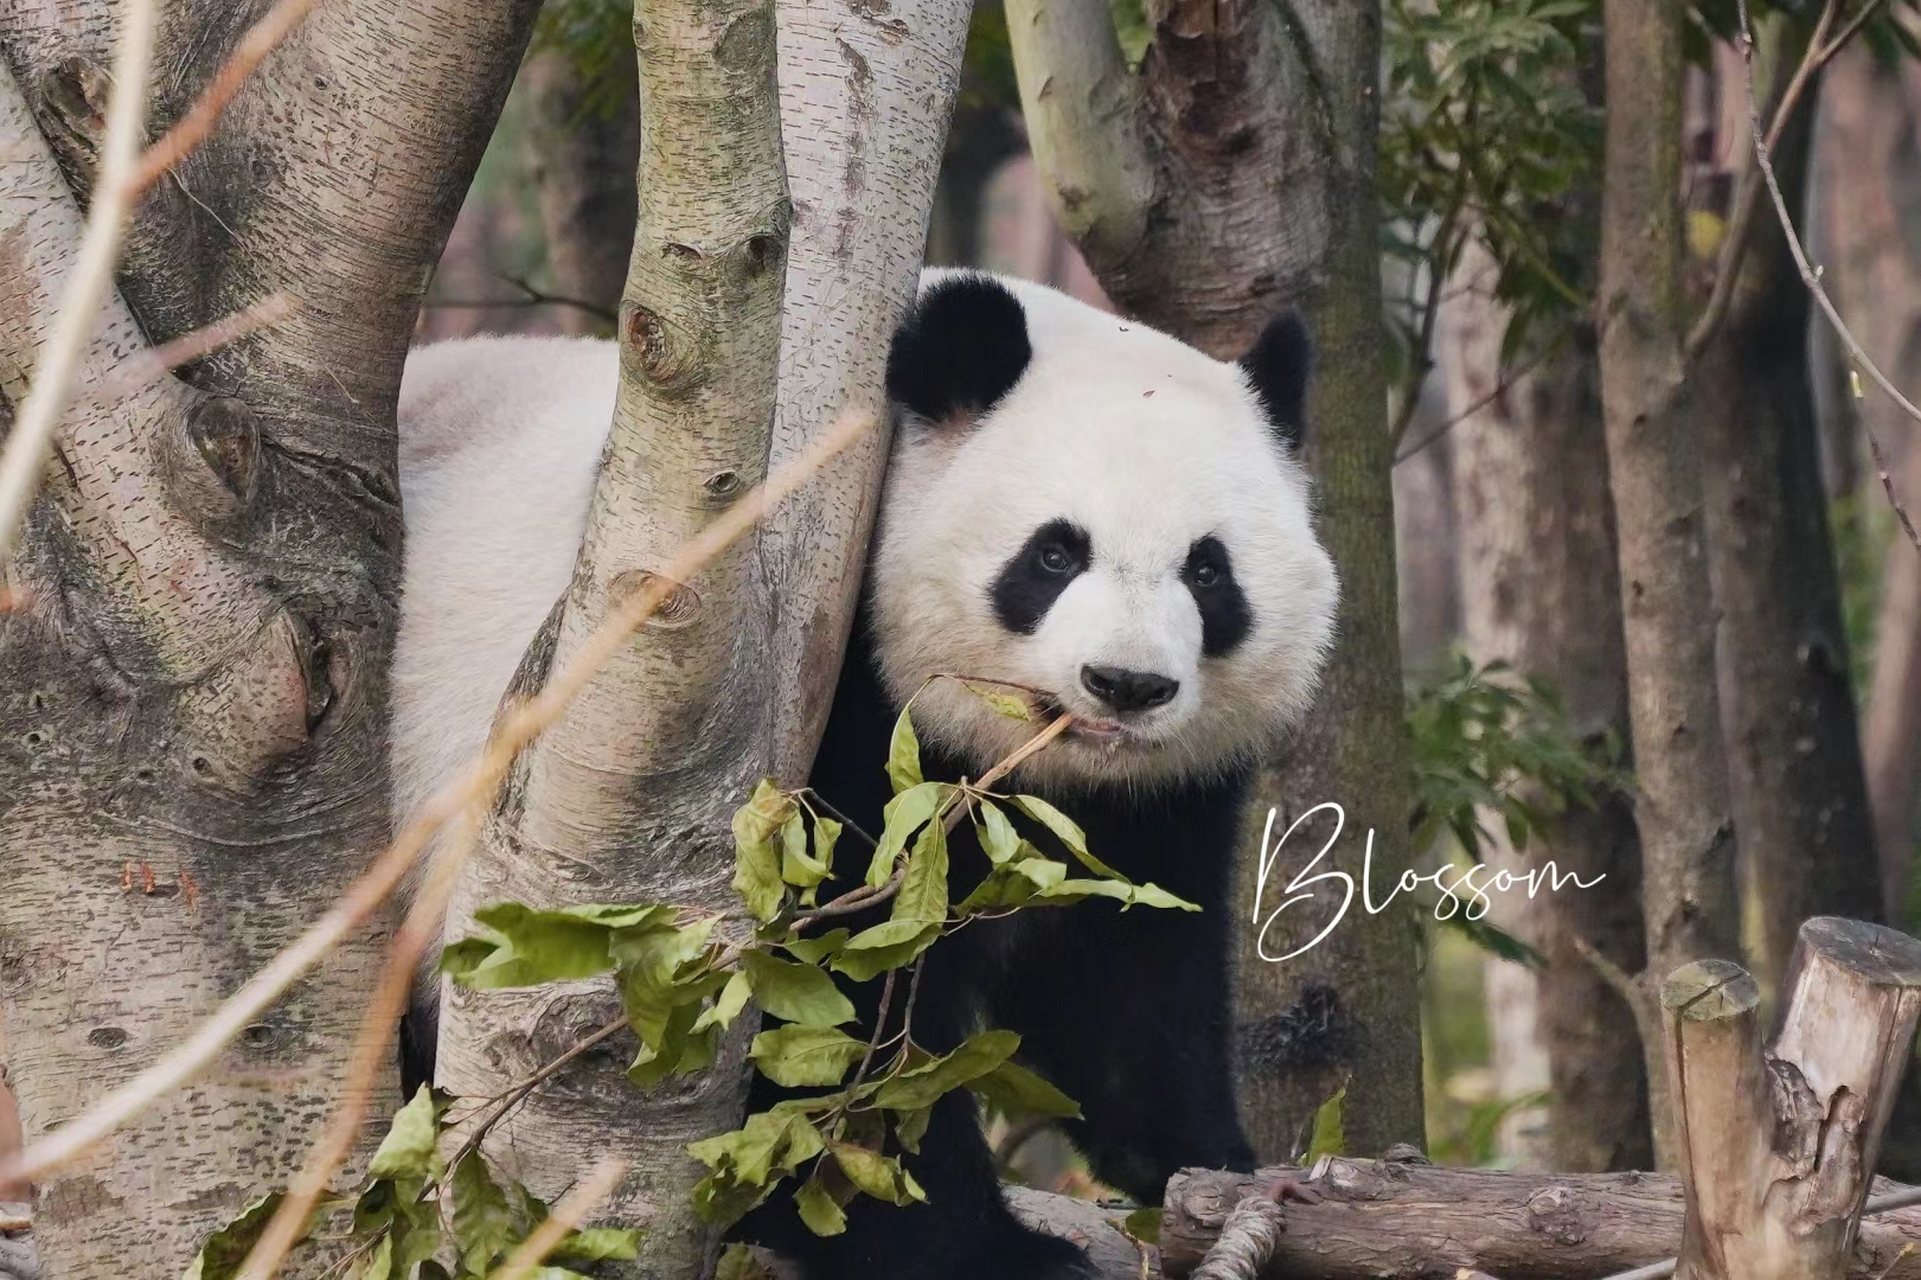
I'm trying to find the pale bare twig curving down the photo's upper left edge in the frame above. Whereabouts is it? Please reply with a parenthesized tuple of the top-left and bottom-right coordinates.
(0, 0, 154, 563)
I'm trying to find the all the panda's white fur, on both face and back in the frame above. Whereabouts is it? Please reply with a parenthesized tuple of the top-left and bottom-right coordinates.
(394, 269, 1335, 815)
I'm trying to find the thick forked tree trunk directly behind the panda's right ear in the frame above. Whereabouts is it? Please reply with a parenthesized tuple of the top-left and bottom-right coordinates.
(1009, 0, 1423, 1157)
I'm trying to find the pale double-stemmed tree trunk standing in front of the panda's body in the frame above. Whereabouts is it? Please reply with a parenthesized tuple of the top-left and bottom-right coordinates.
(438, 0, 966, 1274)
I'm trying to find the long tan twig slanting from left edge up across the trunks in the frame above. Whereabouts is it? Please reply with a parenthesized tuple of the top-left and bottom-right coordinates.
(0, 403, 876, 1180)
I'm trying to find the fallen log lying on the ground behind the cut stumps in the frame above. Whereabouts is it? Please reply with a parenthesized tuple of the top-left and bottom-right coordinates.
(1144, 1159, 1921, 1280)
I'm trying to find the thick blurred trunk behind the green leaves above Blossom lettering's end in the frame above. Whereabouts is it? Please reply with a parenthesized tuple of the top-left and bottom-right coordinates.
(1441, 236, 1652, 1172)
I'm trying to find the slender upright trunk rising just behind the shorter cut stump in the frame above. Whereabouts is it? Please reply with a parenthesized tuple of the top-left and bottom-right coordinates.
(1598, 0, 1737, 1167)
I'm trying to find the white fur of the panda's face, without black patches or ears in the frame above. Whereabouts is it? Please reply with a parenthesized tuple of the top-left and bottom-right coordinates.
(872, 271, 1335, 786)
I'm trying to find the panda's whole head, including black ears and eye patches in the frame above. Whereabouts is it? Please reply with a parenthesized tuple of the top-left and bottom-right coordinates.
(872, 271, 1335, 786)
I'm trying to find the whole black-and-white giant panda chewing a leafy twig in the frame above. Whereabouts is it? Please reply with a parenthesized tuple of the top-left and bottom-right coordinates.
(394, 269, 1337, 1280)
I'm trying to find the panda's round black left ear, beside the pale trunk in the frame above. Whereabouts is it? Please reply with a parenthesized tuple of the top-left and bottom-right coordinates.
(888, 273, 1033, 425)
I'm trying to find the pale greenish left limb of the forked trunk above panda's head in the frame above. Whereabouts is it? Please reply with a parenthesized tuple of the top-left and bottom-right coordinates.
(1007, 0, 1155, 270)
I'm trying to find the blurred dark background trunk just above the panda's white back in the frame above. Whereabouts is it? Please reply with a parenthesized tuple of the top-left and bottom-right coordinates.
(521, 50, 640, 334)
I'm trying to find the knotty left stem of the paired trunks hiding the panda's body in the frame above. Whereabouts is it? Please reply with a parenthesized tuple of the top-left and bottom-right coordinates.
(436, 0, 790, 1276)
